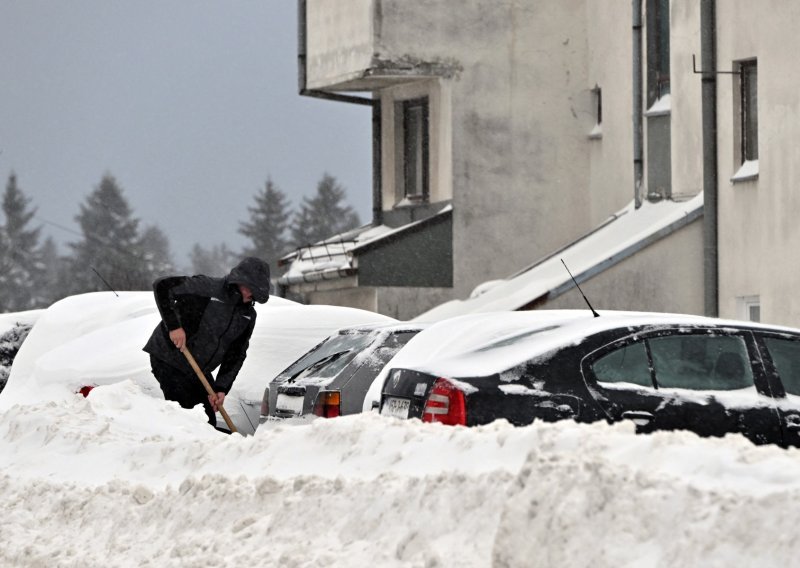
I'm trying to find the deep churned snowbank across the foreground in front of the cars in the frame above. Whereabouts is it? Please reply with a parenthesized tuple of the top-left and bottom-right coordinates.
(0, 301, 800, 568)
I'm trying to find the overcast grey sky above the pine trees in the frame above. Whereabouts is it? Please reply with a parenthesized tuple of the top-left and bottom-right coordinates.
(0, 0, 372, 266)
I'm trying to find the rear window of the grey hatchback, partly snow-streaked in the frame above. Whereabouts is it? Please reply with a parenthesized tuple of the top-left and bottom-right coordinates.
(281, 332, 373, 380)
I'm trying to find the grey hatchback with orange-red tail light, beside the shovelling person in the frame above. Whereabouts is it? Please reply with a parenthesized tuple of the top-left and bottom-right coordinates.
(260, 323, 423, 424)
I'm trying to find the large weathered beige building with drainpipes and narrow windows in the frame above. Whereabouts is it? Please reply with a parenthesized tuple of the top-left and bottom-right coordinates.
(282, 0, 800, 323)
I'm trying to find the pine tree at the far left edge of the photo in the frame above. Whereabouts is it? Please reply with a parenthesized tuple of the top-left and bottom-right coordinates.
(0, 173, 44, 312)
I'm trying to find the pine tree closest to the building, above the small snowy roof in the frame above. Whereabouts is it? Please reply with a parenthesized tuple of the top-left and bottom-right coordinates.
(291, 173, 361, 247)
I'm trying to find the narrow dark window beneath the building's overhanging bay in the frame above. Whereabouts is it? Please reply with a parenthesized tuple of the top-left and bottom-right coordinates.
(396, 97, 430, 201)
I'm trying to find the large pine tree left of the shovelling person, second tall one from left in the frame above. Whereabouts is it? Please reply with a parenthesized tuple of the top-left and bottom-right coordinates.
(70, 174, 152, 294)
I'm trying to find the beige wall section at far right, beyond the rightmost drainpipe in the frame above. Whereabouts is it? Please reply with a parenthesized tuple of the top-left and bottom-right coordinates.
(717, 0, 800, 325)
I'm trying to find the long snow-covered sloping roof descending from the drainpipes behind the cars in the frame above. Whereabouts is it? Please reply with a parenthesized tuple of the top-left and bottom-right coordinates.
(415, 192, 703, 321)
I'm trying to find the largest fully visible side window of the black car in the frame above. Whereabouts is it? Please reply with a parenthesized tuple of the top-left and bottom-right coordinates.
(648, 334, 753, 390)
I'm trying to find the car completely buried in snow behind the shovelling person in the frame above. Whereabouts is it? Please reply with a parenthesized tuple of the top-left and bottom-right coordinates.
(0, 292, 396, 433)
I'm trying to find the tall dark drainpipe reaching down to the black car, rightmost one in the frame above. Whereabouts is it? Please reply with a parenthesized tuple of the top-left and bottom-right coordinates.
(700, 0, 719, 317)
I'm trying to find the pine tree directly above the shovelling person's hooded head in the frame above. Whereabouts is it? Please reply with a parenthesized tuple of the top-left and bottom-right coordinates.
(239, 179, 289, 270)
